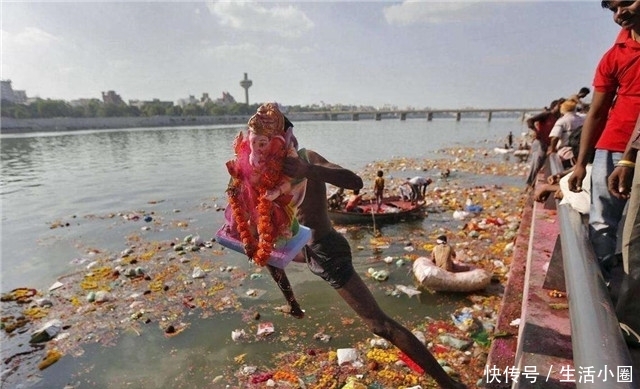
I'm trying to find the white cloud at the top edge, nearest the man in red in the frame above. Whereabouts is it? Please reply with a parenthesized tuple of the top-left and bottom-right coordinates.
(383, 0, 477, 26)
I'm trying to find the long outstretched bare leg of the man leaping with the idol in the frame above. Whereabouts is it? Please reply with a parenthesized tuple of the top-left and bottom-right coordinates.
(336, 273, 466, 389)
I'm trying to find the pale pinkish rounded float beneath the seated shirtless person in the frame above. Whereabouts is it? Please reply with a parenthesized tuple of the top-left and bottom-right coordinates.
(413, 257, 491, 292)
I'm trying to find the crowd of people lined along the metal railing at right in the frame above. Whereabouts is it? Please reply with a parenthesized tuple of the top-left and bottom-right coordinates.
(526, 1, 640, 346)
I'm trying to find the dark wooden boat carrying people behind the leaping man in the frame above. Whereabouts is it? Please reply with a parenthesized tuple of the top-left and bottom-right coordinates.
(329, 196, 425, 224)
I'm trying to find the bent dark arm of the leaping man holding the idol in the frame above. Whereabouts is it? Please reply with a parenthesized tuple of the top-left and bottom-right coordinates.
(282, 150, 363, 189)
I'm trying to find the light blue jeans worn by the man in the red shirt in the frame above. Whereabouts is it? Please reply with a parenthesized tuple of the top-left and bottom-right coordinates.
(589, 149, 626, 262)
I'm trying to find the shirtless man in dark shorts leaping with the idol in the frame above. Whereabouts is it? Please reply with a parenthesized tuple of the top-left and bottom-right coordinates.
(270, 150, 466, 389)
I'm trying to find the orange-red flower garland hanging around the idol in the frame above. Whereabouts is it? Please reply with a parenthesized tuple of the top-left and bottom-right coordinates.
(227, 134, 286, 266)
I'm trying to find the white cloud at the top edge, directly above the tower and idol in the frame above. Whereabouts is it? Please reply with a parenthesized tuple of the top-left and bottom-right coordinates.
(207, 1, 314, 38)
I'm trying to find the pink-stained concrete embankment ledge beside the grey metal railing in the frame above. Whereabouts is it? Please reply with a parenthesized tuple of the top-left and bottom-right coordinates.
(484, 182, 576, 389)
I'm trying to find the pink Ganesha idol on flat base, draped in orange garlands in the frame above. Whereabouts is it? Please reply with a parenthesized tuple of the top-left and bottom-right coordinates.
(218, 103, 310, 267)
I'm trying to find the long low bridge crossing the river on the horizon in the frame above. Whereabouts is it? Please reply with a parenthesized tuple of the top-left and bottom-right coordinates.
(287, 108, 543, 121)
